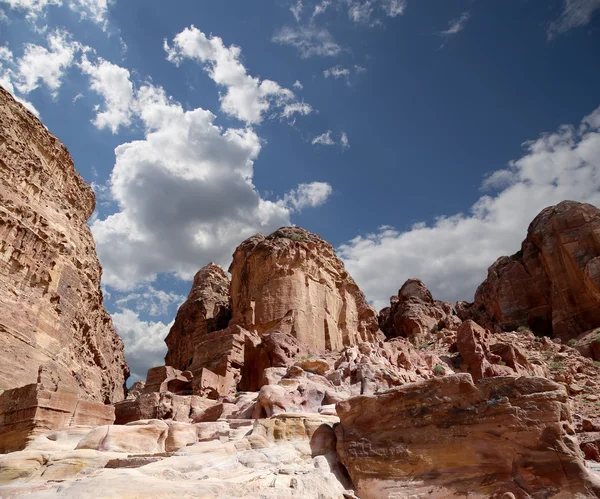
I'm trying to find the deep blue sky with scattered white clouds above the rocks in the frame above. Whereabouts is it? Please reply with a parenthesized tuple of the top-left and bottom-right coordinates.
(0, 0, 600, 381)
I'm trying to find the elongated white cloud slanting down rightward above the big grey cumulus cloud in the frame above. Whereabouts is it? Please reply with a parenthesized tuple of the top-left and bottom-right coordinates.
(164, 26, 311, 124)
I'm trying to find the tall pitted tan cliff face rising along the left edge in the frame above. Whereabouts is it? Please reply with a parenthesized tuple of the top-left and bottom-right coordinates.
(0, 88, 129, 402)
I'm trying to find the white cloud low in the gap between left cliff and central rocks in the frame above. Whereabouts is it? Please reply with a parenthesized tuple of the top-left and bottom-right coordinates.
(112, 308, 173, 381)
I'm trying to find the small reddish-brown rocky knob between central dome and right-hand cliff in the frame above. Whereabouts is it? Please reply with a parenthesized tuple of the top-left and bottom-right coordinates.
(379, 279, 461, 341)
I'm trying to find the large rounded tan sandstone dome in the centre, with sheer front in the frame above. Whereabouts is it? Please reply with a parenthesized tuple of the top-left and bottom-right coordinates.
(229, 227, 378, 350)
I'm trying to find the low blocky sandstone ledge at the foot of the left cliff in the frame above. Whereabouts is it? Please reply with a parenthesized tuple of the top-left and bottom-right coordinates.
(0, 383, 115, 453)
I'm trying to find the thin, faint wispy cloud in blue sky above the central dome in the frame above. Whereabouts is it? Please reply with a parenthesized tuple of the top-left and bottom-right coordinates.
(272, 24, 342, 58)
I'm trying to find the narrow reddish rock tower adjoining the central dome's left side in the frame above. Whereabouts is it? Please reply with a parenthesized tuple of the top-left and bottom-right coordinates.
(165, 263, 231, 371)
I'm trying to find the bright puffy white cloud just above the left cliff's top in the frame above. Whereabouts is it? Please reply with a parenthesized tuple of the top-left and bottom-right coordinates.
(15, 30, 84, 96)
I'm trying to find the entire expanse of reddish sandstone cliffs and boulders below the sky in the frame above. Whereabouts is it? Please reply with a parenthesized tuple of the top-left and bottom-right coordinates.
(0, 94, 600, 499)
